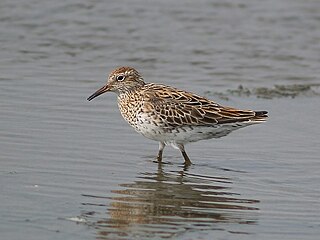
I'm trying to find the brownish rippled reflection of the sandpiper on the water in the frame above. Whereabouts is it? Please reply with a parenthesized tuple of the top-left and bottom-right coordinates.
(81, 164, 259, 239)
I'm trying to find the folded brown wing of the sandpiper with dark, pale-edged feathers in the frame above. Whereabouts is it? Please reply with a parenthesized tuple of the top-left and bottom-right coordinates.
(144, 85, 266, 126)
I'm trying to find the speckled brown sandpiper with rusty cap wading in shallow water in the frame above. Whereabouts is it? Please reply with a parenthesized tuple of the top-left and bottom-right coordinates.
(87, 66, 268, 166)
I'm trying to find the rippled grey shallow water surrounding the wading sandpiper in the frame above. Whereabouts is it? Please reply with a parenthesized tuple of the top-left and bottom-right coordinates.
(0, 0, 320, 240)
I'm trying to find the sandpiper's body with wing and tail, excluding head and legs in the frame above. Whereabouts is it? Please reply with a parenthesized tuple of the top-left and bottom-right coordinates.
(118, 83, 267, 142)
